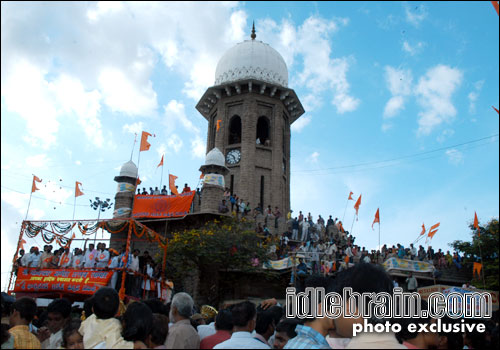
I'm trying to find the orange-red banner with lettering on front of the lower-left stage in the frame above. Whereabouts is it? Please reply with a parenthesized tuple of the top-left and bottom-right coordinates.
(14, 267, 113, 295)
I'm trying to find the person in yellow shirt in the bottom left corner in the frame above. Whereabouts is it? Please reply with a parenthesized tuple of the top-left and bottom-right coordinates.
(9, 297, 42, 349)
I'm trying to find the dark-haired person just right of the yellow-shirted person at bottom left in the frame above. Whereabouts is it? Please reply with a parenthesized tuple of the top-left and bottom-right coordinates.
(38, 298, 71, 349)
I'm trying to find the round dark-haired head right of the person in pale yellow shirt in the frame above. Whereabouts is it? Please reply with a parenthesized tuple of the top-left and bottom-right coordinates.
(122, 301, 153, 342)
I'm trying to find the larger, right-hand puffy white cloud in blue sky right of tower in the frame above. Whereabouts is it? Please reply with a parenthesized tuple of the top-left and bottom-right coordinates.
(415, 65, 463, 135)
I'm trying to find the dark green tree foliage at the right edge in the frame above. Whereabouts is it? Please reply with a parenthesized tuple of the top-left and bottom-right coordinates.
(450, 219, 499, 290)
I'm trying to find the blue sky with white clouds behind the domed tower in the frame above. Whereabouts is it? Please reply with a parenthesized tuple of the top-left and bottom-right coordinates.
(1, 2, 499, 289)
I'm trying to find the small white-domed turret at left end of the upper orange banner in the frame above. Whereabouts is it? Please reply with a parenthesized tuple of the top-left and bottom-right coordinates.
(113, 160, 138, 219)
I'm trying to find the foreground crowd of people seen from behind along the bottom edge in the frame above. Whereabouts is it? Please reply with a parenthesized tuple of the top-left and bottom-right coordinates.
(2, 263, 499, 349)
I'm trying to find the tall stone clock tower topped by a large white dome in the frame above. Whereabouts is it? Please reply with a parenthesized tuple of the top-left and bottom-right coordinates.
(196, 23, 304, 213)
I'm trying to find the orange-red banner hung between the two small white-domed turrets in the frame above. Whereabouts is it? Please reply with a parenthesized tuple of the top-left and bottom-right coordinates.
(132, 191, 195, 218)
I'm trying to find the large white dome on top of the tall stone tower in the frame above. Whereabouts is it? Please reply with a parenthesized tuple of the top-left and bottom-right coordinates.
(215, 40, 288, 87)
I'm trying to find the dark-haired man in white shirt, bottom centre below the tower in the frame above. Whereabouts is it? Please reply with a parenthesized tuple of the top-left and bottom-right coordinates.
(214, 301, 271, 349)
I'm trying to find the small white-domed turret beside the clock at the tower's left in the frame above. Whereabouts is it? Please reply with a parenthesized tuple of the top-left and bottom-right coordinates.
(200, 148, 229, 213)
